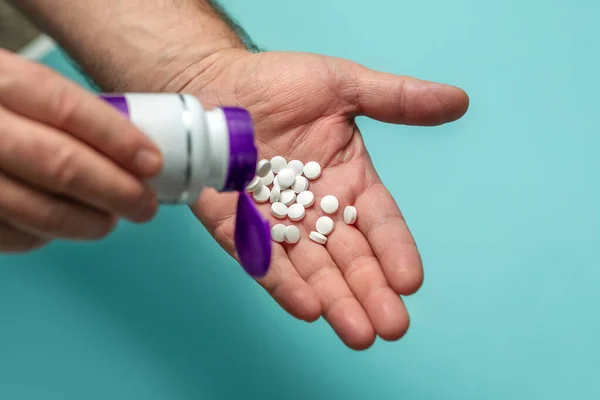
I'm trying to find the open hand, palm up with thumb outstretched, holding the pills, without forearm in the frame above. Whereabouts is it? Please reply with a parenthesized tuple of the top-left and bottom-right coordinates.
(185, 50, 468, 349)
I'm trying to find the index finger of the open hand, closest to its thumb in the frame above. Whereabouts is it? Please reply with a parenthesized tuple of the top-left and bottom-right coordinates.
(354, 183, 423, 295)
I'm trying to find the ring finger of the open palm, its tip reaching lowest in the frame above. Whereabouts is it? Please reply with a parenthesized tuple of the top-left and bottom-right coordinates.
(288, 239, 375, 350)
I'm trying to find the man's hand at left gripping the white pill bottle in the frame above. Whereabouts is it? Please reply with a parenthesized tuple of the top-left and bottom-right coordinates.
(0, 50, 161, 252)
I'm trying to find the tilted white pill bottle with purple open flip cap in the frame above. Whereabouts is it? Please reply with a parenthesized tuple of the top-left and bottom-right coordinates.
(100, 93, 271, 277)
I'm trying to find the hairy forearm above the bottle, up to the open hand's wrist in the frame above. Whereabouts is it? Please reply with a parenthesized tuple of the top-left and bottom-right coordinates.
(13, 0, 256, 91)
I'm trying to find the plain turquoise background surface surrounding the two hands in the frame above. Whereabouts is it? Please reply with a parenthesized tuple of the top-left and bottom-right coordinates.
(0, 0, 600, 400)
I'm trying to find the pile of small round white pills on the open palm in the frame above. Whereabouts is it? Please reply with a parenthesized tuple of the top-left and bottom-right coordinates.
(246, 156, 357, 245)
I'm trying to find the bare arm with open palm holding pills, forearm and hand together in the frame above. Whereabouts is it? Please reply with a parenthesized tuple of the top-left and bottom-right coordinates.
(10, 0, 469, 350)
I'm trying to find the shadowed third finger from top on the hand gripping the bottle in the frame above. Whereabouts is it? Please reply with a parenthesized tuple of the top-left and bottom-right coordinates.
(0, 173, 115, 239)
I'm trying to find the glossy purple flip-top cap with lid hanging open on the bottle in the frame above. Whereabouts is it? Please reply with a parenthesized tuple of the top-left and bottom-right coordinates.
(223, 108, 272, 278)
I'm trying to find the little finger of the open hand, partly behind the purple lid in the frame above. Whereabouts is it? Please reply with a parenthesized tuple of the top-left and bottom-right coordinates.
(258, 243, 322, 322)
